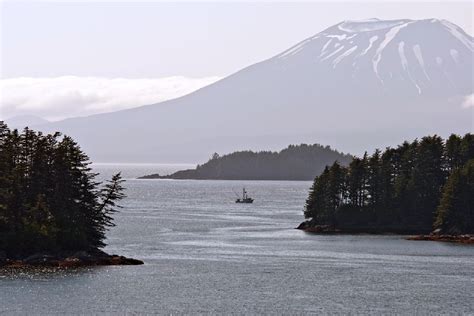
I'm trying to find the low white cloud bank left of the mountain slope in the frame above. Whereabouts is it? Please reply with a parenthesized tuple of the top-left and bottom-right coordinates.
(0, 76, 220, 120)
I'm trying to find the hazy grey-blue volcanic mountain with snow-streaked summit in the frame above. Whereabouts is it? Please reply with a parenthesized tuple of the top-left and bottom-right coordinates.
(32, 19, 474, 162)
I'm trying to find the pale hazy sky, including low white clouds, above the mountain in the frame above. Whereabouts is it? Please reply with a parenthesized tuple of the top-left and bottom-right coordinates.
(0, 1, 473, 119)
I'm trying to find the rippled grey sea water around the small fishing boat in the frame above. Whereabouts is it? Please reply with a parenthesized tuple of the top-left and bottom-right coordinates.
(0, 165, 474, 315)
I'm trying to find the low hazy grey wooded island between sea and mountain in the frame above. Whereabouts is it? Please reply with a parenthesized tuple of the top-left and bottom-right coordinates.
(140, 144, 352, 180)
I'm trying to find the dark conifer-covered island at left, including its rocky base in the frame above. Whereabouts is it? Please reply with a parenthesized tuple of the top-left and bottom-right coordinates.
(0, 121, 143, 267)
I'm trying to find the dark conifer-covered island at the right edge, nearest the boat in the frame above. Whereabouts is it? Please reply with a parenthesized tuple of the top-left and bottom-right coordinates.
(298, 134, 474, 243)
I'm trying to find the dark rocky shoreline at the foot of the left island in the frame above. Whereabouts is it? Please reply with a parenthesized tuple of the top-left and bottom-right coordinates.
(0, 250, 143, 268)
